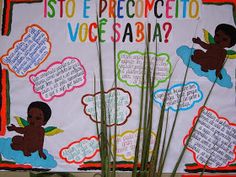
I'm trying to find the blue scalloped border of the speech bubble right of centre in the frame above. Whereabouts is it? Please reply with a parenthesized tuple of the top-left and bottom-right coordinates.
(154, 82, 203, 112)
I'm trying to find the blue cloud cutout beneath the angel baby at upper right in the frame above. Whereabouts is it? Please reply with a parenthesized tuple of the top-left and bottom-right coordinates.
(176, 46, 233, 88)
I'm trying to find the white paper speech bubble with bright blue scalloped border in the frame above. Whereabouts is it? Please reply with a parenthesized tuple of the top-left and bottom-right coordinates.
(154, 82, 203, 111)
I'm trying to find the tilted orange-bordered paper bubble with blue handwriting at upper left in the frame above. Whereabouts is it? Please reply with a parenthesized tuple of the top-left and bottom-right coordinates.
(0, 24, 51, 77)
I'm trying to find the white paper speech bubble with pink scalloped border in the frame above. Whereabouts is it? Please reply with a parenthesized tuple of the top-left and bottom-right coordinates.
(29, 57, 86, 101)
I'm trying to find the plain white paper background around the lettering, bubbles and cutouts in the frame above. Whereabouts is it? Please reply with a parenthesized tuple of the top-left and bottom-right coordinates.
(0, 2, 236, 172)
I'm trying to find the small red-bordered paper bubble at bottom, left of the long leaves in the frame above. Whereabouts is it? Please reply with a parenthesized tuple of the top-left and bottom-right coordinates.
(59, 136, 99, 164)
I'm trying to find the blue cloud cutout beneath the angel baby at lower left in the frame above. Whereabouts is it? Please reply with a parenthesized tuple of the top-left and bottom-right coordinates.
(0, 138, 57, 169)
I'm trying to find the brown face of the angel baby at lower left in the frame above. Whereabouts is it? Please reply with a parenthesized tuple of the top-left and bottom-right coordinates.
(27, 108, 44, 127)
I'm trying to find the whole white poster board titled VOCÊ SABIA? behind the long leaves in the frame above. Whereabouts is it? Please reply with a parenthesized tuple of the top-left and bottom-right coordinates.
(0, 0, 236, 173)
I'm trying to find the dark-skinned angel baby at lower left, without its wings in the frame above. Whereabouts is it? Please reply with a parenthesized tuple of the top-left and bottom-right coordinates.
(7, 101, 51, 159)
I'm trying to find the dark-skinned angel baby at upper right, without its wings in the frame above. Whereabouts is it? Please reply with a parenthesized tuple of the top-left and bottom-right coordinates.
(191, 24, 236, 79)
